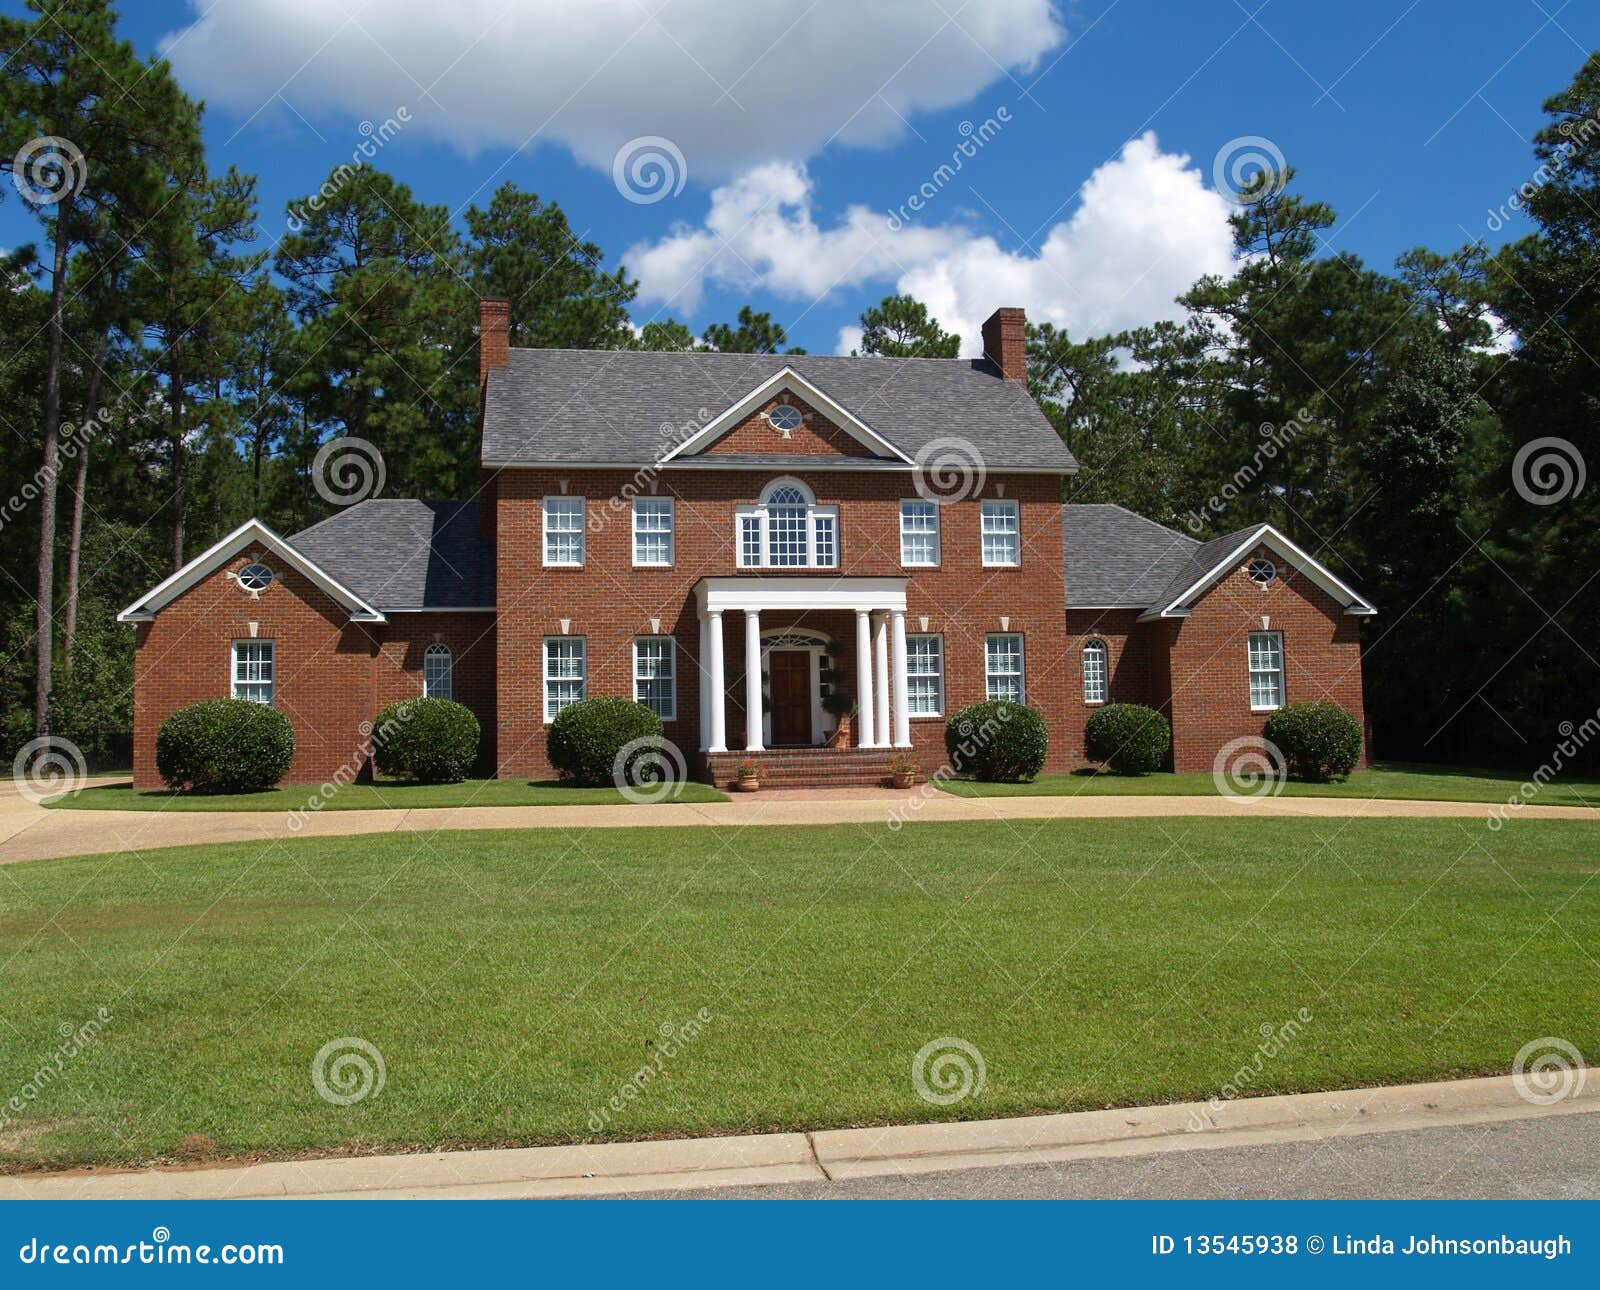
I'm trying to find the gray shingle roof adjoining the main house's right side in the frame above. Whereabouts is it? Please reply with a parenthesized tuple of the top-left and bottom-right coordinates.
(1061, 504, 1200, 610)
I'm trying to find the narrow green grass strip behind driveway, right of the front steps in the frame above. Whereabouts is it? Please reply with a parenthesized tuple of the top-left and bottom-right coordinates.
(939, 762, 1600, 807)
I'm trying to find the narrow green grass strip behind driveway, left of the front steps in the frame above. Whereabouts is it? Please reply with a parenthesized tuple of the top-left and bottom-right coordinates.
(43, 779, 728, 811)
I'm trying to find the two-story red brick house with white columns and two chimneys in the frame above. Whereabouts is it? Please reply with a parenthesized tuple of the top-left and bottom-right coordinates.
(122, 301, 1373, 786)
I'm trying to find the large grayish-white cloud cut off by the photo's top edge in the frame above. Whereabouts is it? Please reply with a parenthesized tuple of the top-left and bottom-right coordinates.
(163, 0, 1066, 179)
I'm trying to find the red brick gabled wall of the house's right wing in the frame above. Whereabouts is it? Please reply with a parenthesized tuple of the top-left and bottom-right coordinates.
(1152, 551, 1365, 771)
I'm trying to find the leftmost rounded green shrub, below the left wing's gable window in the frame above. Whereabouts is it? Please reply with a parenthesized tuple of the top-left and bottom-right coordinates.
(155, 699, 294, 792)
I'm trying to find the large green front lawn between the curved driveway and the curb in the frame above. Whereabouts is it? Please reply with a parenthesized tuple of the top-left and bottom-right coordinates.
(0, 819, 1600, 1167)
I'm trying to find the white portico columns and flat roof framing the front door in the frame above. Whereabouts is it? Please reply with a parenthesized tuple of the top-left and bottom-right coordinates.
(694, 576, 910, 754)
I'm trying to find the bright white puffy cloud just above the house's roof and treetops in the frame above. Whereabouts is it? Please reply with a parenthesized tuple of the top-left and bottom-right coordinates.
(624, 134, 1234, 354)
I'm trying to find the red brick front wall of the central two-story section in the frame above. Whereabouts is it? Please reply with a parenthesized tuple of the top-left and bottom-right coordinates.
(496, 471, 1069, 778)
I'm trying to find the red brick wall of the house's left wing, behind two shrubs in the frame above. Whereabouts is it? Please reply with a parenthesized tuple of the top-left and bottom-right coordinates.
(133, 552, 494, 787)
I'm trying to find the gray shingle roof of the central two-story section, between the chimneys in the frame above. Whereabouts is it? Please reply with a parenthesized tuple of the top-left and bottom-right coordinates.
(483, 349, 1077, 472)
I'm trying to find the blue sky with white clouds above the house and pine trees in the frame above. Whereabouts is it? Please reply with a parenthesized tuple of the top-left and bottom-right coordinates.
(0, 0, 1600, 352)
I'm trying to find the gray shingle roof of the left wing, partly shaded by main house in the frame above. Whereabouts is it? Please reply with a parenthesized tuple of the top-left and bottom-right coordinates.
(288, 498, 494, 610)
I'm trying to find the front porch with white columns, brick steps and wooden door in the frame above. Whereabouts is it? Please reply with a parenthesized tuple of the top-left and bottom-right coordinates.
(694, 576, 912, 768)
